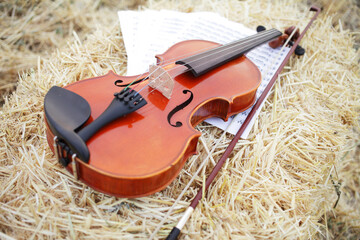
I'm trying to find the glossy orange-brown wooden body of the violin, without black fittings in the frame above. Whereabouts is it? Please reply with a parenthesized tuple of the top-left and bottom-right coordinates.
(46, 40, 261, 198)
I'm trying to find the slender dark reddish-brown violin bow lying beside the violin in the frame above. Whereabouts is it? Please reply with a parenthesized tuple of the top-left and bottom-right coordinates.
(153, 6, 321, 240)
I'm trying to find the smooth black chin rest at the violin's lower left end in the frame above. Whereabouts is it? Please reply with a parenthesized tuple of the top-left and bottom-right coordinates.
(44, 86, 91, 162)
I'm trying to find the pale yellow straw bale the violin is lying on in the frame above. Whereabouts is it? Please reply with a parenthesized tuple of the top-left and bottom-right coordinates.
(0, 0, 360, 239)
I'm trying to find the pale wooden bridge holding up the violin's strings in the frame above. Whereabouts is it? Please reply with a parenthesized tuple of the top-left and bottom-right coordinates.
(149, 65, 175, 99)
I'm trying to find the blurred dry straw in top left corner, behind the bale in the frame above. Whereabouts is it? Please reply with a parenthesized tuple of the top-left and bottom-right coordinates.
(0, 0, 139, 103)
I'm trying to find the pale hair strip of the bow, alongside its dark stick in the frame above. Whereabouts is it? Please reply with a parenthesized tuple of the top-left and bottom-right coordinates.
(150, 27, 298, 240)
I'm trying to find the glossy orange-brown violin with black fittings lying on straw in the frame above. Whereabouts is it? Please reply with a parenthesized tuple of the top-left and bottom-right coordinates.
(44, 26, 296, 198)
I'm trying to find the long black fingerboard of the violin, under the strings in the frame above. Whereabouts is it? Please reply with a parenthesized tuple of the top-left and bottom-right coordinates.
(176, 29, 282, 77)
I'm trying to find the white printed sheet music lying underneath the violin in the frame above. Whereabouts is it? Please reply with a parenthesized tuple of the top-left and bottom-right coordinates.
(118, 10, 290, 138)
